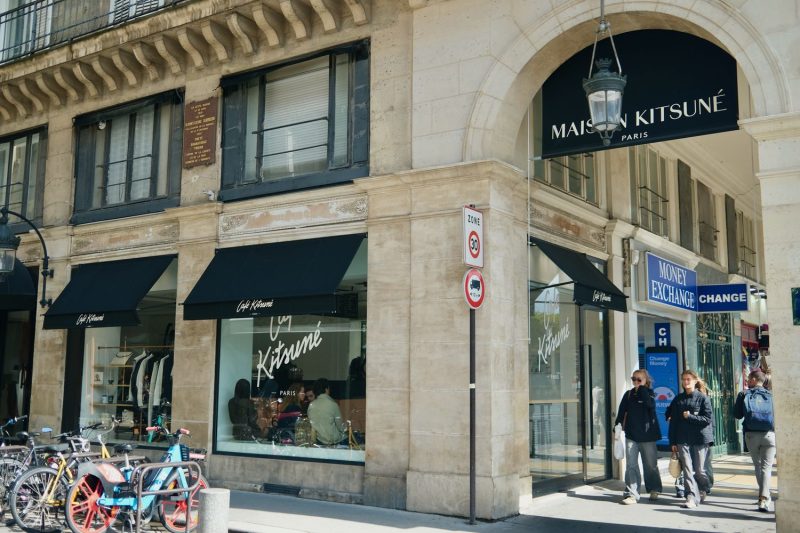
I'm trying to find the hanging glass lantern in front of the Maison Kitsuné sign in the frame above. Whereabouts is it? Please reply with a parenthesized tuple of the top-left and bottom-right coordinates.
(583, 0, 627, 146)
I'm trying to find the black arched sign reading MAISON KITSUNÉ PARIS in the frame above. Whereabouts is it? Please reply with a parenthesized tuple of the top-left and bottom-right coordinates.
(541, 30, 739, 158)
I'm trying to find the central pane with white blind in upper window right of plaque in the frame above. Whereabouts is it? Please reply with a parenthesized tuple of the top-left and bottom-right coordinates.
(261, 57, 330, 180)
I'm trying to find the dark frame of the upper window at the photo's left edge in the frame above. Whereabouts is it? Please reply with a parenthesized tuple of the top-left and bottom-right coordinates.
(0, 126, 47, 233)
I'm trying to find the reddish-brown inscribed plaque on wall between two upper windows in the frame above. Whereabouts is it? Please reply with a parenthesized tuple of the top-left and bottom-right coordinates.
(183, 96, 219, 168)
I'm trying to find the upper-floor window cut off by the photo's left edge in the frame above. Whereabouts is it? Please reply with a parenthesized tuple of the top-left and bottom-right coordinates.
(0, 130, 47, 225)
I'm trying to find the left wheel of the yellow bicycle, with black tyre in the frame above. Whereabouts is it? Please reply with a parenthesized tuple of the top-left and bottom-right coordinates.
(8, 466, 67, 533)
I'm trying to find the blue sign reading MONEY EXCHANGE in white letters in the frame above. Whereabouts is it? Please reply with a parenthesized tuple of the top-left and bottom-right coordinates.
(647, 252, 697, 311)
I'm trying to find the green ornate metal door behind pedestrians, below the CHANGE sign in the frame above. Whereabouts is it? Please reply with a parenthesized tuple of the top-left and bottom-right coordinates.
(697, 313, 739, 454)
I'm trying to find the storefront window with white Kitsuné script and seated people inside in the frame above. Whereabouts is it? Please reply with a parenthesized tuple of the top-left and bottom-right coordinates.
(215, 240, 367, 462)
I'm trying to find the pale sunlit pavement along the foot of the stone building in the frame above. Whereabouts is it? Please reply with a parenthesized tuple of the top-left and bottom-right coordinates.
(0, 455, 779, 533)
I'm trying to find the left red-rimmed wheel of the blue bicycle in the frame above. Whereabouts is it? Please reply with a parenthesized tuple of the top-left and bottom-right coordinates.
(64, 474, 118, 533)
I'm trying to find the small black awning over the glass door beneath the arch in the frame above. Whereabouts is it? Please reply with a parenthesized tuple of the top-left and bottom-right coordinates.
(530, 237, 628, 313)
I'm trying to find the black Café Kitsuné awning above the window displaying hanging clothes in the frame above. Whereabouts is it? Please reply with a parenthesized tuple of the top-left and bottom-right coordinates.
(44, 255, 175, 329)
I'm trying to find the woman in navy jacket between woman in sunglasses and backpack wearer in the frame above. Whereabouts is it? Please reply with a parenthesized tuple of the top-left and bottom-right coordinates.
(666, 370, 714, 509)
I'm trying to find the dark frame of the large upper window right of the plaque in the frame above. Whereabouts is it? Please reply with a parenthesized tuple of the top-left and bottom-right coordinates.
(218, 40, 370, 201)
